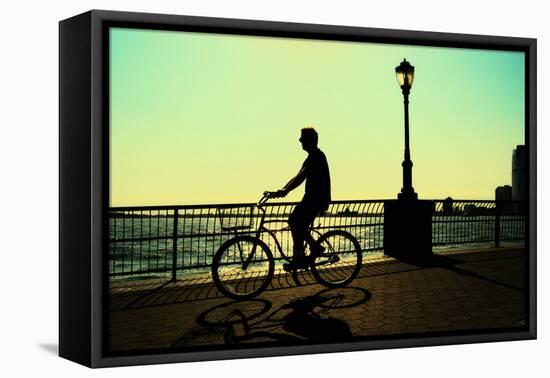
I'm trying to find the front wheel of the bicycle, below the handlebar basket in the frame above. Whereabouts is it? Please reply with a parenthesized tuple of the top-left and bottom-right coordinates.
(212, 235, 275, 299)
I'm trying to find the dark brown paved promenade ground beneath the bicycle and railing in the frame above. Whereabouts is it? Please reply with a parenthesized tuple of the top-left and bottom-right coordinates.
(108, 247, 527, 352)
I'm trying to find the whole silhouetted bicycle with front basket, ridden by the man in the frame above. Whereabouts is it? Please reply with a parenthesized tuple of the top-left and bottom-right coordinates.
(212, 192, 362, 300)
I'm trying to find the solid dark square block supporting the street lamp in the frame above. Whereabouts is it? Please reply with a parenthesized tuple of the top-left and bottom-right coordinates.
(384, 201, 433, 260)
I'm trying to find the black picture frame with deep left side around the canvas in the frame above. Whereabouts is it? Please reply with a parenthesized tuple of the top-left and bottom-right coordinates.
(59, 10, 537, 368)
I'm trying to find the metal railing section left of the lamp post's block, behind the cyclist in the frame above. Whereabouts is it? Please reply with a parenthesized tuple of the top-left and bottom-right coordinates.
(109, 200, 384, 278)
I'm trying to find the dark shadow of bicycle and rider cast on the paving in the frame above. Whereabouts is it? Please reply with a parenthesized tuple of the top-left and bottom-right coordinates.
(172, 287, 371, 347)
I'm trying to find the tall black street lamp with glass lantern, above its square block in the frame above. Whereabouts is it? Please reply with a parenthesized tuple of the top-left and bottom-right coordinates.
(395, 59, 418, 199)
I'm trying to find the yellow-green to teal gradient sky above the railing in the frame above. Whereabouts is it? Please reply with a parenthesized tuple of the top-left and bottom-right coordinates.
(110, 28, 525, 206)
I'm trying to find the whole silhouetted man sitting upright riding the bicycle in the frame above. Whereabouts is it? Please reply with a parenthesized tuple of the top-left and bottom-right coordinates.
(276, 127, 330, 268)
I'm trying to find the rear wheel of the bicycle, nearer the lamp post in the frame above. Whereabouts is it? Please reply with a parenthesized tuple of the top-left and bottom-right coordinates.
(311, 230, 362, 288)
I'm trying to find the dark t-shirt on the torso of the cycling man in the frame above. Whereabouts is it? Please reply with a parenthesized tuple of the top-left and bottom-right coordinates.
(302, 148, 330, 210)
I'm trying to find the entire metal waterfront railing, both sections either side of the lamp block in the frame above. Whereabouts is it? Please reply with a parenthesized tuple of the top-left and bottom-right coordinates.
(108, 200, 526, 279)
